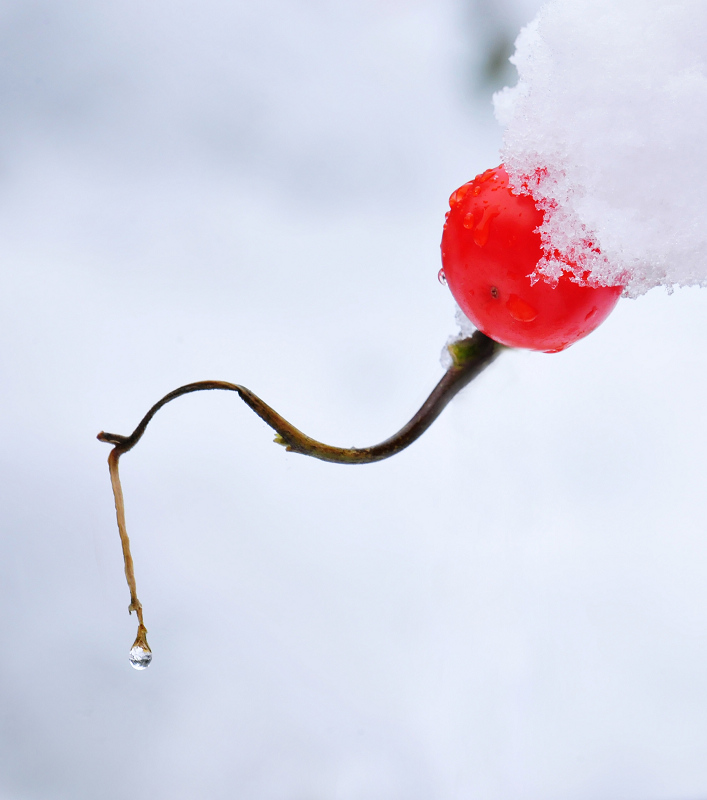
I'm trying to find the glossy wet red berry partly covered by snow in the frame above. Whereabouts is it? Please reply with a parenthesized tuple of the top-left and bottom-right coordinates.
(442, 166, 623, 353)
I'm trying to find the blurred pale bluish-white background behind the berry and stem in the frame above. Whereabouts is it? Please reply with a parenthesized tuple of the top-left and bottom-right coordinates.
(0, 0, 707, 800)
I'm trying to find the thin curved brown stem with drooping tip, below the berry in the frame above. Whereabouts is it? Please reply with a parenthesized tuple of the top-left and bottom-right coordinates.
(98, 331, 503, 649)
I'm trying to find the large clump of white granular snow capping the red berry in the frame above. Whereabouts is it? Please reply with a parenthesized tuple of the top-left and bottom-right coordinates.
(494, 0, 707, 296)
